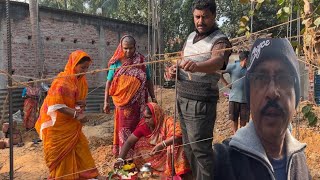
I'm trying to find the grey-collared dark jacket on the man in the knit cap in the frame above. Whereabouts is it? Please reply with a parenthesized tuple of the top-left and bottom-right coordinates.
(213, 121, 311, 180)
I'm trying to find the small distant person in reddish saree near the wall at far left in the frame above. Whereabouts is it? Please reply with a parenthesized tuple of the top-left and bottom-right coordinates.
(22, 79, 40, 130)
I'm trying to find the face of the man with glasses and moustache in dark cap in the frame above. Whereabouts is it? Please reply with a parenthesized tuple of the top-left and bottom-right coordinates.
(249, 59, 296, 142)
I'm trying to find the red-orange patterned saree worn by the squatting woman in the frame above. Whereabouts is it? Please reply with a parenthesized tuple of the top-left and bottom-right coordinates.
(134, 103, 190, 177)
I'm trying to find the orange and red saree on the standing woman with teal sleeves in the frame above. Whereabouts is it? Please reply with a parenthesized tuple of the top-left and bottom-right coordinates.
(108, 37, 147, 157)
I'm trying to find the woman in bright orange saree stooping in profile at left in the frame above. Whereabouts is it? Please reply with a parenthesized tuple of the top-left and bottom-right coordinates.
(36, 50, 99, 179)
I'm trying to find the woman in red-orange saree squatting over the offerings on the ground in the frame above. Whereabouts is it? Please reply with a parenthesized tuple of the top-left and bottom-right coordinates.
(115, 103, 191, 178)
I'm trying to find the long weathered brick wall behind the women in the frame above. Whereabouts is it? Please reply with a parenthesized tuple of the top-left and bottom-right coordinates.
(0, 0, 148, 89)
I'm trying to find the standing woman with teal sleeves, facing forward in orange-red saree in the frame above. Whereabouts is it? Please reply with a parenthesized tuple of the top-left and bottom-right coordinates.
(104, 36, 156, 157)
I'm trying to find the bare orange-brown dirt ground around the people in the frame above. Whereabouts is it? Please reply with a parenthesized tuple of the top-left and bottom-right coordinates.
(0, 89, 320, 180)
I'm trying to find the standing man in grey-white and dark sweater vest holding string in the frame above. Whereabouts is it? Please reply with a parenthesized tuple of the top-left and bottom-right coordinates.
(169, 0, 231, 180)
